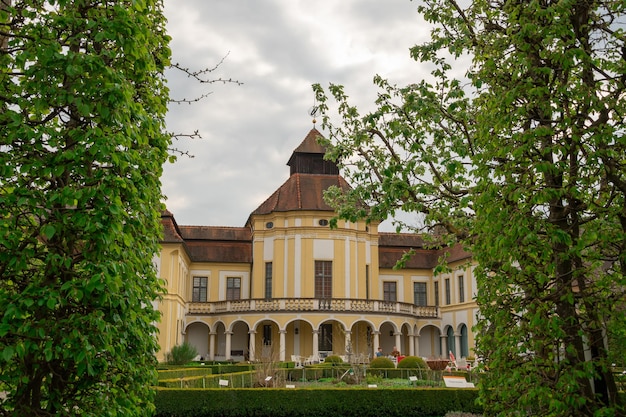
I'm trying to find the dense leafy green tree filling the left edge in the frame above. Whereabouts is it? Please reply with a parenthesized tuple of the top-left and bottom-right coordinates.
(0, 0, 171, 416)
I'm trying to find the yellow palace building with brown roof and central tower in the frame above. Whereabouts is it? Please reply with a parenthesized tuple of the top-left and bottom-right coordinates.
(156, 128, 478, 362)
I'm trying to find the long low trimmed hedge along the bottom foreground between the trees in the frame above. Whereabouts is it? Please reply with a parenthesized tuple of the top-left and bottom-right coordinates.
(155, 388, 482, 417)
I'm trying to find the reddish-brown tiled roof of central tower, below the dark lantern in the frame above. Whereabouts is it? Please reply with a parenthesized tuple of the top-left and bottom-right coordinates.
(252, 174, 350, 215)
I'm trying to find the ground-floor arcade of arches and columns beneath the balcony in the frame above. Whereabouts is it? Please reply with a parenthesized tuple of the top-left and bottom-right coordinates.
(178, 303, 473, 363)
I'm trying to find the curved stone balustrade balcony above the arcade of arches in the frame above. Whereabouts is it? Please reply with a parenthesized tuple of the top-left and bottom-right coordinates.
(187, 298, 439, 318)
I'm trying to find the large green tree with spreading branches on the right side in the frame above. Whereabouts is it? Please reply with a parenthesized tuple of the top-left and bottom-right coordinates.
(314, 0, 626, 416)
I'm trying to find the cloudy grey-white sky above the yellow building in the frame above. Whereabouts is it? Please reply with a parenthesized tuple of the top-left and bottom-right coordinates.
(162, 0, 428, 230)
